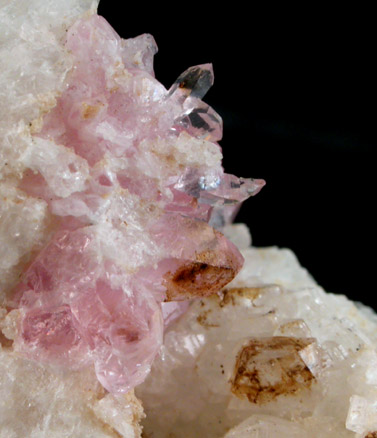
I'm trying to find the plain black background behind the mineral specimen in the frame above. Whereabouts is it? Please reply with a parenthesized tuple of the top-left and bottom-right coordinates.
(99, 4, 377, 308)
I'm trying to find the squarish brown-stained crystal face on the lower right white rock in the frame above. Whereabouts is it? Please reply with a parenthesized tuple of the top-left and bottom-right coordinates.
(231, 336, 314, 404)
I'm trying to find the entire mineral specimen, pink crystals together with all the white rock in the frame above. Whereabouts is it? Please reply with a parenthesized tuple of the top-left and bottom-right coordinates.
(0, 0, 377, 438)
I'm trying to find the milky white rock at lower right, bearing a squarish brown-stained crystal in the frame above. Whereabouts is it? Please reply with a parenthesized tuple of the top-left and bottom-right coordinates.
(137, 225, 377, 438)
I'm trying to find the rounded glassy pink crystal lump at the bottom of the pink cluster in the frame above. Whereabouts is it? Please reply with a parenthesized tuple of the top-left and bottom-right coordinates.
(15, 227, 162, 392)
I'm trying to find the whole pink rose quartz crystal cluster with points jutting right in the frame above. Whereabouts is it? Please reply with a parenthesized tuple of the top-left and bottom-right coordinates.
(11, 15, 264, 393)
